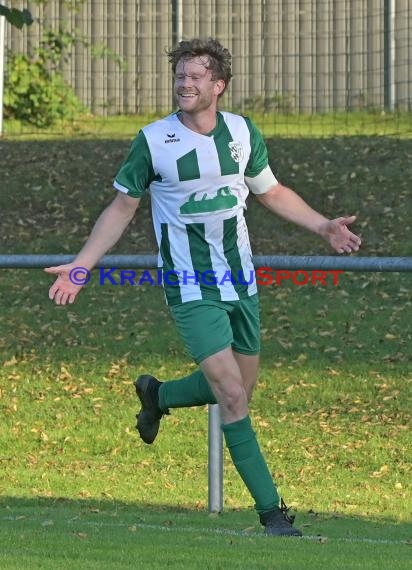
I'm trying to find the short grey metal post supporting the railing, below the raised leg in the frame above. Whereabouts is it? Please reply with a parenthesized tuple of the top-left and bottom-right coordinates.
(208, 404, 223, 513)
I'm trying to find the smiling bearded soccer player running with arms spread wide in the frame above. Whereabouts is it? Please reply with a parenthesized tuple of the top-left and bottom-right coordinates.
(46, 38, 361, 536)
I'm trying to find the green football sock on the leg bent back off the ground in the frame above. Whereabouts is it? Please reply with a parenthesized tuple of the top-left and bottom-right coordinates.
(159, 370, 216, 410)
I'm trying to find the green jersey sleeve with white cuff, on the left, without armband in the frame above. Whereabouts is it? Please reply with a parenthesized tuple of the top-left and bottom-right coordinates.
(113, 131, 155, 198)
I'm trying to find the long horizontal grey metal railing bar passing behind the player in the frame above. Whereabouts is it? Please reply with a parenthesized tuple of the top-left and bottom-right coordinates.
(0, 254, 412, 272)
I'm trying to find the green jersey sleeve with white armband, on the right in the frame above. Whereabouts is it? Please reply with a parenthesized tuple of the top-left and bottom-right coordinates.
(245, 117, 278, 194)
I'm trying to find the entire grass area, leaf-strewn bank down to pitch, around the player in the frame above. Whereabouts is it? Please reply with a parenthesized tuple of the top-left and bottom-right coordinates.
(0, 114, 412, 570)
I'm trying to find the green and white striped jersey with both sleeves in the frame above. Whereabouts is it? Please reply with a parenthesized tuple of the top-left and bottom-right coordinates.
(114, 112, 276, 305)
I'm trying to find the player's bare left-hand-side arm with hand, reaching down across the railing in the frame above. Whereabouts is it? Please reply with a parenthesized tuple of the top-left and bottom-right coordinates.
(44, 192, 140, 305)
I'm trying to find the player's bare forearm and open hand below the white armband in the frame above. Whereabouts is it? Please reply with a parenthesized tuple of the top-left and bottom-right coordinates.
(255, 183, 361, 253)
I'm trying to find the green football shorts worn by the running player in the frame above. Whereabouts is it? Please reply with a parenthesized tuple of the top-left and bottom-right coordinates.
(170, 295, 260, 364)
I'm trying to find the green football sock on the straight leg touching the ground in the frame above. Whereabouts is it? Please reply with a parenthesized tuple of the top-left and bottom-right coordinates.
(222, 416, 280, 513)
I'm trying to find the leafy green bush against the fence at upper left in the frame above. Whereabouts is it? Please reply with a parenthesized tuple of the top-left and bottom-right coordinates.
(4, 31, 84, 128)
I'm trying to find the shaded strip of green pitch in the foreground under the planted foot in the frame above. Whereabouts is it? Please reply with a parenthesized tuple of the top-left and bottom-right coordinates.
(0, 500, 411, 570)
